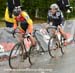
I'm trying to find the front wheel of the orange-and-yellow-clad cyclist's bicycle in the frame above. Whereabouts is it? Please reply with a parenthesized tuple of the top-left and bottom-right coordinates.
(9, 43, 25, 69)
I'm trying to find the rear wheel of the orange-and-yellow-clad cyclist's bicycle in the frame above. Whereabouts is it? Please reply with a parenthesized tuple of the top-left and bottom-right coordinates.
(29, 43, 44, 65)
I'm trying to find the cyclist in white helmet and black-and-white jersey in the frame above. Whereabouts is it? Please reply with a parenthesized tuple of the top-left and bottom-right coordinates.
(48, 4, 70, 45)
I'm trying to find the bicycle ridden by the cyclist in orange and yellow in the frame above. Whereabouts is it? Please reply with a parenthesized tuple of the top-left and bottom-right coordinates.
(5, 29, 45, 69)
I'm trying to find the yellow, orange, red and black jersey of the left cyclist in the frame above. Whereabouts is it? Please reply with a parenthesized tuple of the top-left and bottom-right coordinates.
(14, 11, 33, 33)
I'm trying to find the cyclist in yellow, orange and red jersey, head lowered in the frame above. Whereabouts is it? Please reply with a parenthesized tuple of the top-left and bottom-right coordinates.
(13, 6, 35, 46)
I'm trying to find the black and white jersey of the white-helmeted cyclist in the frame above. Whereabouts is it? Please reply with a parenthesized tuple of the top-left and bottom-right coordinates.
(48, 11, 64, 26)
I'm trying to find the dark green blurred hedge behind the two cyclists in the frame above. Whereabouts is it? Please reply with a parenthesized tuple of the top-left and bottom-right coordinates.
(0, 0, 75, 20)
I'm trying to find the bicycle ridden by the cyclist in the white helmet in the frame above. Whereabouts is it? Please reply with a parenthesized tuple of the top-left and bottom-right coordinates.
(47, 26, 65, 58)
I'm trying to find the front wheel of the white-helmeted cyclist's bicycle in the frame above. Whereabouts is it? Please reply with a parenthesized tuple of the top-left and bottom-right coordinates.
(48, 37, 63, 58)
